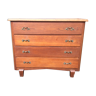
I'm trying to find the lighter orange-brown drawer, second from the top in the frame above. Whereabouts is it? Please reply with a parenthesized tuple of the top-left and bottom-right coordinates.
(14, 35, 82, 46)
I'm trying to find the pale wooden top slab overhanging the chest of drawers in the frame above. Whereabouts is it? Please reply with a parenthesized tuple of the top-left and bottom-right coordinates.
(8, 17, 90, 23)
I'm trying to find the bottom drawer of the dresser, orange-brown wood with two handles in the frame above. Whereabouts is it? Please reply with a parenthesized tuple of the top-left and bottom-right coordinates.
(16, 57, 79, 68)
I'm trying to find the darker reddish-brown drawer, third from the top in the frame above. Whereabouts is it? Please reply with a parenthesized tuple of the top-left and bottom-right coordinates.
(14, 46, 80, 58)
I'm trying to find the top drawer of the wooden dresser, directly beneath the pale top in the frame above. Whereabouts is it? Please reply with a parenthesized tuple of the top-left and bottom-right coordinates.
(11, 21, 85, 34)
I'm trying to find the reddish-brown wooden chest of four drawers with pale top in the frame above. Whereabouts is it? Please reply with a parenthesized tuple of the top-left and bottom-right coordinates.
(8, 17, 90, 79)
